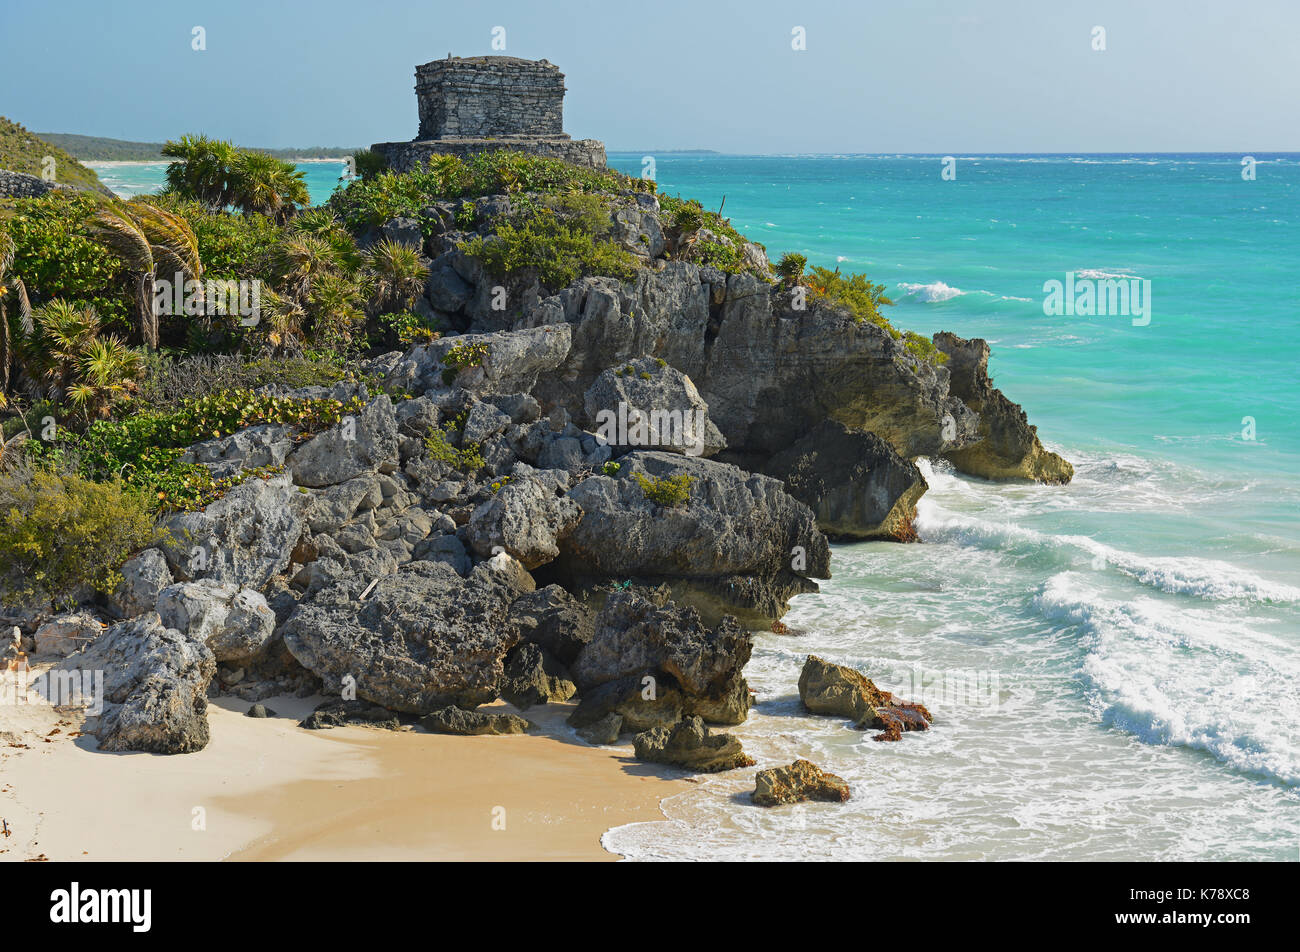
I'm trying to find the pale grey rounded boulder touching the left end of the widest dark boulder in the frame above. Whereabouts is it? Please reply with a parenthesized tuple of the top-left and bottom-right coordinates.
(467, 477, 582, 568)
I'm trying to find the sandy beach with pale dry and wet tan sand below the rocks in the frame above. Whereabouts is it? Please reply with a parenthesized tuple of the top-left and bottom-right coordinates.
(0, 666, 685, 861)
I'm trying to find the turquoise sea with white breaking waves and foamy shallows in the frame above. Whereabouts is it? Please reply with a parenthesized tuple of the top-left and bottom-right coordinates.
(94, 153, 1300, 861)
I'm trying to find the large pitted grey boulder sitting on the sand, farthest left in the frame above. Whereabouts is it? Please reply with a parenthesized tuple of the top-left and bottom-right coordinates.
(35, 611, 216, 753)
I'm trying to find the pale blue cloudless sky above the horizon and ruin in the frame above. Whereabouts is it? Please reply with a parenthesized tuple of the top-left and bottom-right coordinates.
(0, 0, 1300, 153)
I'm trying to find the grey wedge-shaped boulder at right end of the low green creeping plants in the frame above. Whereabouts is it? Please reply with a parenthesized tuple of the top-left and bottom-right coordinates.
(287, 394, 400, 488)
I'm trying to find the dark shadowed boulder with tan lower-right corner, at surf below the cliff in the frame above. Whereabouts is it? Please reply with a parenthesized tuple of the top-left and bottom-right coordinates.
(763, 420, 928, 541)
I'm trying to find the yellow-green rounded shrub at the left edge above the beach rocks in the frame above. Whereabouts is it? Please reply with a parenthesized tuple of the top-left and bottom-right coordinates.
(0, 464, 161, 609)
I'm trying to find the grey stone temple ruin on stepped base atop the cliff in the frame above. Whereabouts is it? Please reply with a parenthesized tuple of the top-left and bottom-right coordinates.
(371, 53, 605, 172)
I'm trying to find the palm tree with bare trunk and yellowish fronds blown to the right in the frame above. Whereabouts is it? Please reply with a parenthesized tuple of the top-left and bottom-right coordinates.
(90, 199, 203, 350)
